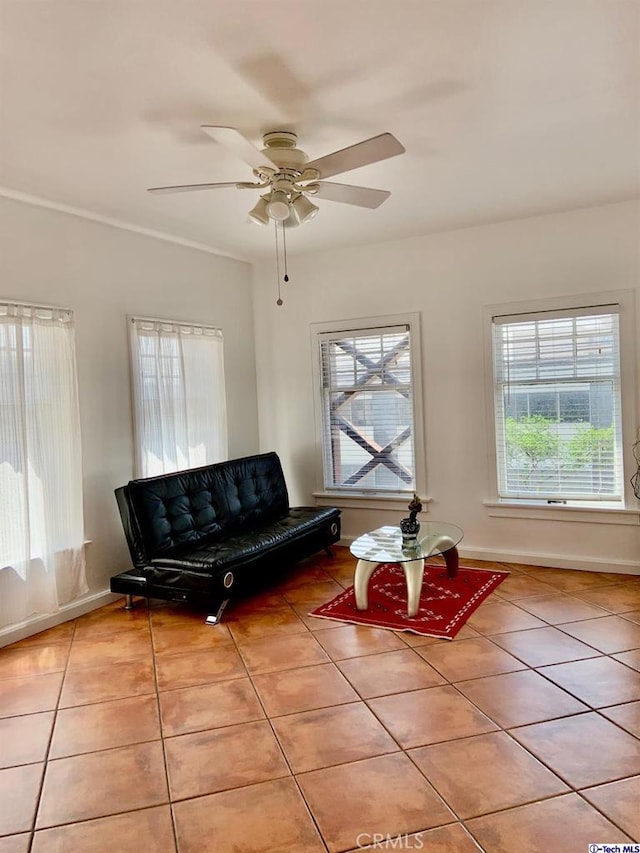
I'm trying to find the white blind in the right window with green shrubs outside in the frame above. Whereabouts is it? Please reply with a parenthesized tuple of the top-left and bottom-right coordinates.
(493, 305, 624, 502)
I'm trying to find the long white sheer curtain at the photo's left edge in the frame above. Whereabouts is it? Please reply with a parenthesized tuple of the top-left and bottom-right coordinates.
(0, 302, 88, 628)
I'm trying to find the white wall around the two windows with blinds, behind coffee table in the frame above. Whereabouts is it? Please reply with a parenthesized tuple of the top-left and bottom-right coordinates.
(254, 202, 640, 570)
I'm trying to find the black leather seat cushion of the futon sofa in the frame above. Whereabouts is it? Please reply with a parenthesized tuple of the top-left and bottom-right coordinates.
(149, 507, 340, 573)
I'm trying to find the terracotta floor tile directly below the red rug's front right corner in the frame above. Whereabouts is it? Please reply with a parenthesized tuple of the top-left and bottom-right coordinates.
(417, 637, 525, 681)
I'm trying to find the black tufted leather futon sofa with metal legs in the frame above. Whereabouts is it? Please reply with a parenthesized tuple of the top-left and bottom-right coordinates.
(111, 453, 340, 623)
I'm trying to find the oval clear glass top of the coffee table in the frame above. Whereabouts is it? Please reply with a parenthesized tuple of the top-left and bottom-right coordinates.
(349, 521, 464, 563)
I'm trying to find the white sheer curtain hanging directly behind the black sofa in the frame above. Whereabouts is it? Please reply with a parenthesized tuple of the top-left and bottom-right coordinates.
(130, 317, 227, 477)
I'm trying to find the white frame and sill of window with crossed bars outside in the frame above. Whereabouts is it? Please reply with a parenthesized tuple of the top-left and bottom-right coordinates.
(310, 312, 429, 511)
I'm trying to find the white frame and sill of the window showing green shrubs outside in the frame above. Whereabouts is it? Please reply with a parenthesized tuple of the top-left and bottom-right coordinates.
(483, 290, 640, 524)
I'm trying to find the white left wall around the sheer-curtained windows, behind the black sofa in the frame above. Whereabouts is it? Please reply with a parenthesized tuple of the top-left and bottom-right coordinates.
(0, 193, 258, 620)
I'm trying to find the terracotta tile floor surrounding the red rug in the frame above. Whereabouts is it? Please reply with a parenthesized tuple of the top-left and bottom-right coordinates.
(0, 548, 640, 853)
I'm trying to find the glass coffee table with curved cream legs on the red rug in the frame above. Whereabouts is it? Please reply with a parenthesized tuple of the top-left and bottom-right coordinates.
(350, 521, 464, 617)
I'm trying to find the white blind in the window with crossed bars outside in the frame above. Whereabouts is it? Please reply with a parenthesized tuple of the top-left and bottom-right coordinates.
(318, 325, 415, 493)
